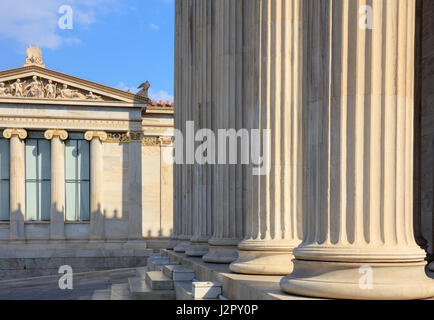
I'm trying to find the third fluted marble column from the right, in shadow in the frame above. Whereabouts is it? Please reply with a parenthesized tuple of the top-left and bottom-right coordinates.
(203, 0, 245, 263)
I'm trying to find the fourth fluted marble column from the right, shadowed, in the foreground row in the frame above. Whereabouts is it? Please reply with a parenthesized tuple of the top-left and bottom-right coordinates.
(186, 0, 215, 257)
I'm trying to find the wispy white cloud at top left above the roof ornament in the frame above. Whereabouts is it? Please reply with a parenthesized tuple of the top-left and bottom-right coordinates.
(0, 0, 118, 49)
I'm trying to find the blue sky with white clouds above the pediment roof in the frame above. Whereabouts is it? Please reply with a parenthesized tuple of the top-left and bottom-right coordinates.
(0, 0, 174, 101)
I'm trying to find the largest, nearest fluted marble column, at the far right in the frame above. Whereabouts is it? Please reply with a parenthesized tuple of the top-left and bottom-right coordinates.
(281, 0, 434, 299)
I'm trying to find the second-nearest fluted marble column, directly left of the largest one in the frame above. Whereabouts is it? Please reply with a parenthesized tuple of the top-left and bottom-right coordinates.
(230, 0, 303, 275)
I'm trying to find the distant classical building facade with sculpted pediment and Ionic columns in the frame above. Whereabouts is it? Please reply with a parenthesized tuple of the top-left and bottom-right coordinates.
(0, 46, 173, 278)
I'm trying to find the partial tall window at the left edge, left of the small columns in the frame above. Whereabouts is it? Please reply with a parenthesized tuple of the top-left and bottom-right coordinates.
(0, 131, 10, 221)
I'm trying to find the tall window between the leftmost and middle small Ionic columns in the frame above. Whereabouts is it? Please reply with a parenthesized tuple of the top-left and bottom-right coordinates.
(25, 132, 51, 221)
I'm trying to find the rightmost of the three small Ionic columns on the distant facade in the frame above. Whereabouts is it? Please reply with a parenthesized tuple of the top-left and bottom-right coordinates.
(84, 131, 107, 240)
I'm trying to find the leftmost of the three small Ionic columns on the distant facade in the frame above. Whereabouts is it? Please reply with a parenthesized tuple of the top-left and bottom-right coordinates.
(3, 129, 27, 240)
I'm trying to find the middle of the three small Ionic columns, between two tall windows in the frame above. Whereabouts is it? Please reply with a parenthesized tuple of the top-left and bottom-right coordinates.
(44, 130, 68, 240)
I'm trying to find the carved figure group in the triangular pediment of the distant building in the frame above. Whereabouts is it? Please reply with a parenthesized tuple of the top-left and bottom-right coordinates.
(0, 76, 104, 101)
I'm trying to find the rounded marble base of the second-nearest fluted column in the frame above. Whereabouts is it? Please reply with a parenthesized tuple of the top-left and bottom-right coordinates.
(229, 250, 294, 276)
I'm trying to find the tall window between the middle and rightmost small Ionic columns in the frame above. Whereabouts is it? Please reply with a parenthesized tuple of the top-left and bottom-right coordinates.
(65, 133, 90, 221)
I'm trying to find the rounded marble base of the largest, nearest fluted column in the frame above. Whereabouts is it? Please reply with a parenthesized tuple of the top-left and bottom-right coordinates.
(280, 259, 434, 300)
